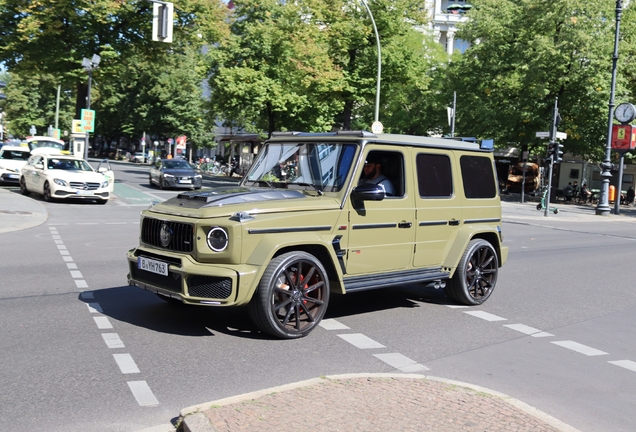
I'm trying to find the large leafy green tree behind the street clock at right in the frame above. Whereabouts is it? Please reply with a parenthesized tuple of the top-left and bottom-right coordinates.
(447, 0, 626, 158)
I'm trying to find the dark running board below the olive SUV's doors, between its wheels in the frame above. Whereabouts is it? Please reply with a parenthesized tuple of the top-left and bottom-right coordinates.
(343, 267, 450, 293)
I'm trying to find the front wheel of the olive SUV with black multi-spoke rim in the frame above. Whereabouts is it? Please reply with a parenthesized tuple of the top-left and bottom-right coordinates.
(249, 252, 329, 339)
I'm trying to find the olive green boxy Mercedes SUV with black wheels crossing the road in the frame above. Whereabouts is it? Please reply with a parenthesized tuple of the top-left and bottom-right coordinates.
(128, 131, 508, 338)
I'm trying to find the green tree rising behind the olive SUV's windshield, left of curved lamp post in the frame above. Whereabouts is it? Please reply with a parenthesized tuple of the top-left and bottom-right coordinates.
(210, 0, 343, 133)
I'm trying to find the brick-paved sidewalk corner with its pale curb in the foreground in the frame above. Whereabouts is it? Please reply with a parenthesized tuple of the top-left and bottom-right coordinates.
(179, 374, 576, 432)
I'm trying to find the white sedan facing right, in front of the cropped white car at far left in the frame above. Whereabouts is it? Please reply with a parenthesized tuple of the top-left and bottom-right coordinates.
(20, 149, 115, 204)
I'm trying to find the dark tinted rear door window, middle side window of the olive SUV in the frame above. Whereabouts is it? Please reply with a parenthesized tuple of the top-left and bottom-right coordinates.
(416, 153, 453, 198)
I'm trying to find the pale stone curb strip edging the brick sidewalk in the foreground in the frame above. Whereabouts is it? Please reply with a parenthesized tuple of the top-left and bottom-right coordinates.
(179, 373, 579, 432)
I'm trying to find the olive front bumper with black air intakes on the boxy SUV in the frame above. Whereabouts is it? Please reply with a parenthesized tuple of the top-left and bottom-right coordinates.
(127, 248, 260, 306)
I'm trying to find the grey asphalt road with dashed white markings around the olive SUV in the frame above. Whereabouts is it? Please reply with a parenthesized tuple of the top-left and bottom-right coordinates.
(0, 164, 636, 431)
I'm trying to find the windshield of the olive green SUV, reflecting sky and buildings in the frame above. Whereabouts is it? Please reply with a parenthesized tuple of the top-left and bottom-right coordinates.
(245, 142, 357, 192)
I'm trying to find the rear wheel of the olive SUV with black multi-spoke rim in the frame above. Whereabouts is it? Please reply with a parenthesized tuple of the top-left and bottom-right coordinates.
(448, 239, 499, 306)
